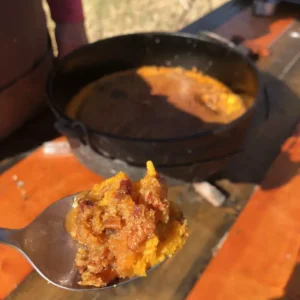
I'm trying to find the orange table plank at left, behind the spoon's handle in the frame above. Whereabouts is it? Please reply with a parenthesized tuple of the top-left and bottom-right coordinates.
(0, 139, 102, 299)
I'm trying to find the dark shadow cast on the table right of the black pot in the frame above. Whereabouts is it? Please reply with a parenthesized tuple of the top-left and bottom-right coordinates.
(221, 74, 300, 189)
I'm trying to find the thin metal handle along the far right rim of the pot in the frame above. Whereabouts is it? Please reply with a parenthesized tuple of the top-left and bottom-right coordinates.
(199, 30, 257, 60)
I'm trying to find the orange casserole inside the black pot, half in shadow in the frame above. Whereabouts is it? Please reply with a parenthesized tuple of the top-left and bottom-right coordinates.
(66, 66, 253, 139)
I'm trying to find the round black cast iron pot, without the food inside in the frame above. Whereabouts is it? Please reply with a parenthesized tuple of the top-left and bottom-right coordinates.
(48, 32, 261, 168)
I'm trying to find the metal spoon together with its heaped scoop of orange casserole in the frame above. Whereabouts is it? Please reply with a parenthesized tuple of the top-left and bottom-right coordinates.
(0, 162, 188, 290)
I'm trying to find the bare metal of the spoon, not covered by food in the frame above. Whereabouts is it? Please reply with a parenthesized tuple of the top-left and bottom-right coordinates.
(0, 194, 156, 291)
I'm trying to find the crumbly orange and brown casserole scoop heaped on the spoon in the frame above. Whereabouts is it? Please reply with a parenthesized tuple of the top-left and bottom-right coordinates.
(66, 162, 188, 287)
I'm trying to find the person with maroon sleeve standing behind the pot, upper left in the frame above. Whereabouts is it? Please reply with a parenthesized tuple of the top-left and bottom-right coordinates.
(0, 0, 87, 140)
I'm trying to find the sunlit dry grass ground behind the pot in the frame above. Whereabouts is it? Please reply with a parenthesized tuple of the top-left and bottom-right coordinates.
(45, 0, 228, 52)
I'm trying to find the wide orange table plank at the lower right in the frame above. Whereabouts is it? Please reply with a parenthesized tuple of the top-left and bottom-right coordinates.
(187, 124, 300, 300)
